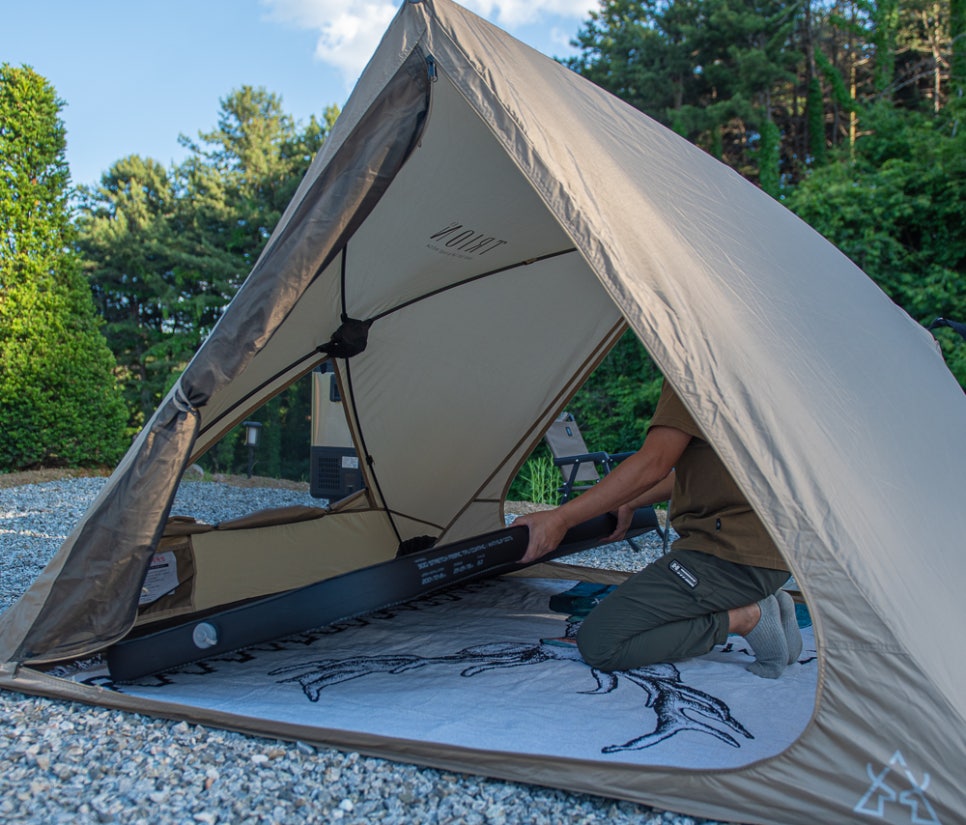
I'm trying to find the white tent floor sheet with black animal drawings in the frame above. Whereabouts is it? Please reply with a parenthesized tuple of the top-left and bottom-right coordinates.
(51, 577, 817, 770)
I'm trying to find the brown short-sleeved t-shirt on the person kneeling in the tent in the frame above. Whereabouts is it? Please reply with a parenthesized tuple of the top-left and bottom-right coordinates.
(651, 381, 788, 570)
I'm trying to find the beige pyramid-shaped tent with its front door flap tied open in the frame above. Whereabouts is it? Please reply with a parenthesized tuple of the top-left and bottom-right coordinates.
(0, 0, 966, 825)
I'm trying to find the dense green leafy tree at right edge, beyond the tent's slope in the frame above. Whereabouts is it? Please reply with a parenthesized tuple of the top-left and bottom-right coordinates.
(787, 99, 966, 385)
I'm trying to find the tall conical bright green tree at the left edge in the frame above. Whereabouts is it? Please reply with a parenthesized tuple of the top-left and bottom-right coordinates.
(0, 64, 125, 470)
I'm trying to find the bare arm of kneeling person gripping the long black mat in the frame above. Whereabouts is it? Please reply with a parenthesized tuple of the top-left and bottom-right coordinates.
(513, 427, 691, 563)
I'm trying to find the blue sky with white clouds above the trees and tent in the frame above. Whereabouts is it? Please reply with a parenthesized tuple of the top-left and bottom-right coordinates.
(0, 0, 598, 184)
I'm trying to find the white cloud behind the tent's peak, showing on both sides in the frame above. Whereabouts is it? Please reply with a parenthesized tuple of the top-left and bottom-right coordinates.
(262, 0, 598, 85)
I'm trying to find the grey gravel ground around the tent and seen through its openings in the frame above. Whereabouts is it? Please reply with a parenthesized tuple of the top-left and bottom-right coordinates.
(0, 478, 740, 825)
